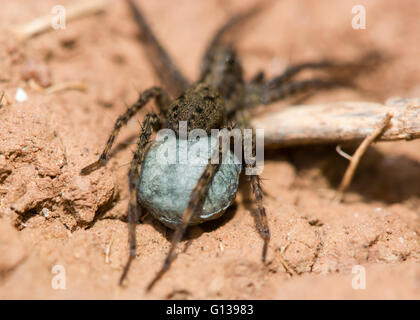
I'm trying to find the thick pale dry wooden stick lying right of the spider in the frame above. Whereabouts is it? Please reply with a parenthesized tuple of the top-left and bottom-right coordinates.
(251, 98, 420, 147)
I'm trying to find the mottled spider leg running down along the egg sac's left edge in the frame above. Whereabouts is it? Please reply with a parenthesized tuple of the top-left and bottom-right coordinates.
(120, 113, 162, 285)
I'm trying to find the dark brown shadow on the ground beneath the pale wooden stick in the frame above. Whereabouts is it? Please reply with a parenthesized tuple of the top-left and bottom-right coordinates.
(266, 144, 420, 204)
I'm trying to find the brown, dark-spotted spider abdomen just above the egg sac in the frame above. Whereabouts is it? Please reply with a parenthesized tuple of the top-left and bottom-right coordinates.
(166, 83, 226, 134)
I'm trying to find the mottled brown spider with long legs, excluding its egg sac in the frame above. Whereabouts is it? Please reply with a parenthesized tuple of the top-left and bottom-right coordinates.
(81, 0, 378, 289)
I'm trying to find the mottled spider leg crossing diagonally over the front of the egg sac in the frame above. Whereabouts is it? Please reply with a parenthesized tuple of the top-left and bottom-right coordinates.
(147, 129, 228, 291)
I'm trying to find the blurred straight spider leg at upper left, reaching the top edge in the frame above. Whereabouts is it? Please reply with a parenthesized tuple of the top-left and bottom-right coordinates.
(127, 0, 189, 97)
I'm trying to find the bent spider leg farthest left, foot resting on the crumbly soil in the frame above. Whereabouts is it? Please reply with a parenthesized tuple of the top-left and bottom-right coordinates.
(80, 87, 169, 175)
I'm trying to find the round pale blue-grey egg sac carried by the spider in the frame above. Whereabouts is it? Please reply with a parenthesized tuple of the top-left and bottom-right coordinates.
(137, 137, 242, 229)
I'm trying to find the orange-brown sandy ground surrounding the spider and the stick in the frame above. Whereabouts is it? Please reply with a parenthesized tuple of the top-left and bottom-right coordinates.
(0, 0, 420, 299)
